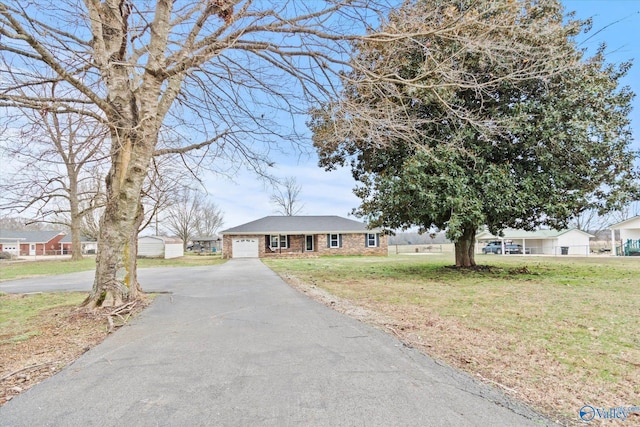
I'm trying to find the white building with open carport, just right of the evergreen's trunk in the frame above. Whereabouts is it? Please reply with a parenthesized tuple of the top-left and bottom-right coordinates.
(476, 228, 594, 255)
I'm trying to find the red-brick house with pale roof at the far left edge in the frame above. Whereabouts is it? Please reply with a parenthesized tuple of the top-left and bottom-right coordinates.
(0, 229, 65, 256)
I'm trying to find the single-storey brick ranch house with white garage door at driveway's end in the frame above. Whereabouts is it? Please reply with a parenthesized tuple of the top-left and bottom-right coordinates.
(221, 216, 387, 258)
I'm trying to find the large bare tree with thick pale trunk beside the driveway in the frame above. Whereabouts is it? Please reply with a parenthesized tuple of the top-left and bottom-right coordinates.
(0, 0, 392, 306)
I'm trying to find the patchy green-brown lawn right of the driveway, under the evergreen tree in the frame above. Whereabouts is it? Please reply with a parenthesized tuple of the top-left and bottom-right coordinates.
(265, 255, 640, 421)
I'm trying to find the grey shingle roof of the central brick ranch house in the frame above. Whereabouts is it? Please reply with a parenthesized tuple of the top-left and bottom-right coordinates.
(221, 215, 381, 235)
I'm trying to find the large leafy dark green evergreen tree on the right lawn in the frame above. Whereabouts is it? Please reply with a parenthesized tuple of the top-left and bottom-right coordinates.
(310, 0, 638, 266)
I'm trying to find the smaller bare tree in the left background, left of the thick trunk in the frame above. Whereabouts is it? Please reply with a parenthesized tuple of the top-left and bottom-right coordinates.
(0, 86, 107, 260)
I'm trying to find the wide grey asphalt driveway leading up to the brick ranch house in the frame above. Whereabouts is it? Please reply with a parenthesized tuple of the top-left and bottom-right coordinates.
(0, 259, 549, 427)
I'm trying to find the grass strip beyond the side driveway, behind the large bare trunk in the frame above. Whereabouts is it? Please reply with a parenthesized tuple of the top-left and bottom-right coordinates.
(0, 255, 225, 281)
